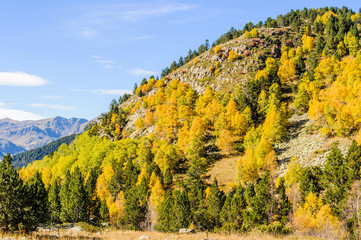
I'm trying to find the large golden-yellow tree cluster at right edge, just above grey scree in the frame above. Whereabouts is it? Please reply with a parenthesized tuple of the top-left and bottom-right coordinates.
(309, 57, 361, 135)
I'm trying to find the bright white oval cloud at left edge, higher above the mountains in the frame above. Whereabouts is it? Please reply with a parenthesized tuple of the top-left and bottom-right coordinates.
(0, 72, 48, 87)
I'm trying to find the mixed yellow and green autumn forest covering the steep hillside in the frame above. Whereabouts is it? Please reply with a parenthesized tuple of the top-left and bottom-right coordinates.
(0, 7, 361, 239)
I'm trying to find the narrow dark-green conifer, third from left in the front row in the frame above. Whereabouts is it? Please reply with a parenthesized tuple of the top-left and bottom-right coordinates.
(48, 180, 61, 224)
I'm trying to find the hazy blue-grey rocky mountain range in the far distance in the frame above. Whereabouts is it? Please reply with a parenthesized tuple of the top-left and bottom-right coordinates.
(0, 117, 88, 157)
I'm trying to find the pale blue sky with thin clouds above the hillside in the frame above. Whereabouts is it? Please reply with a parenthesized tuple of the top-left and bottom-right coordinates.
(0, 0, 361, 120)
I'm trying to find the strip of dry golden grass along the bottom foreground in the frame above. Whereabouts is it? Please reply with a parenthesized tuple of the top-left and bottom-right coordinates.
(0, 230, 321, 240)
